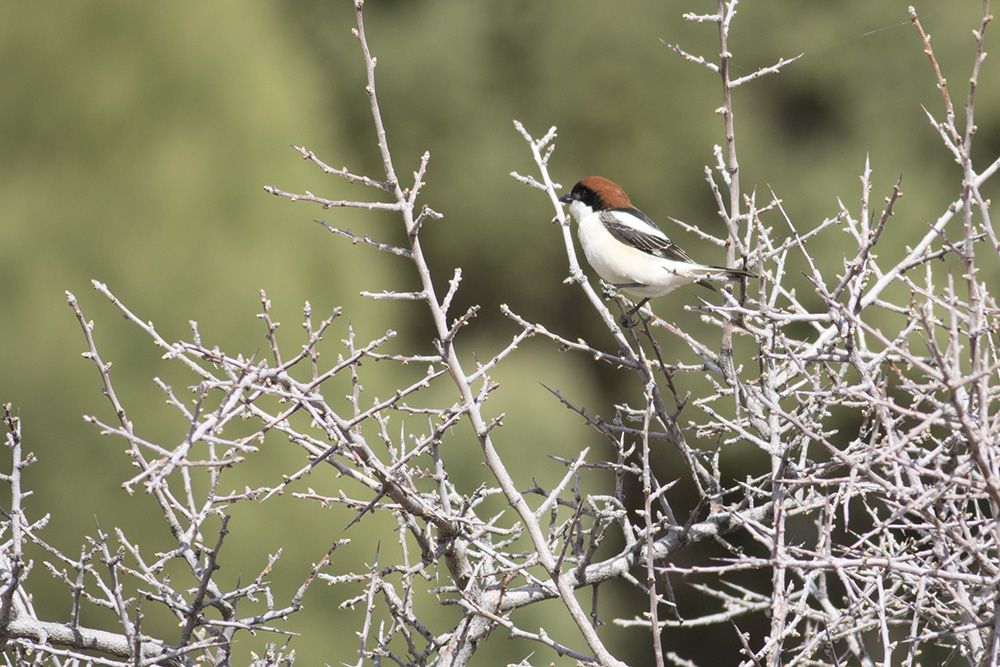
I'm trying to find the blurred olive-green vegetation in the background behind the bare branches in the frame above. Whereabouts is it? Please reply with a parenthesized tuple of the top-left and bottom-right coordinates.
(0, 0, 1000, 665)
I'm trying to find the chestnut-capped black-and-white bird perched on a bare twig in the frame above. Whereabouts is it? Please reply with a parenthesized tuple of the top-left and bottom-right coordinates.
(559, 176, 756, 327)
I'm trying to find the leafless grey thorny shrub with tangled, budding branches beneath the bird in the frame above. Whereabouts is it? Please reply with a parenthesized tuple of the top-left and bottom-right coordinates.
(0, 0, 1000, 665)
